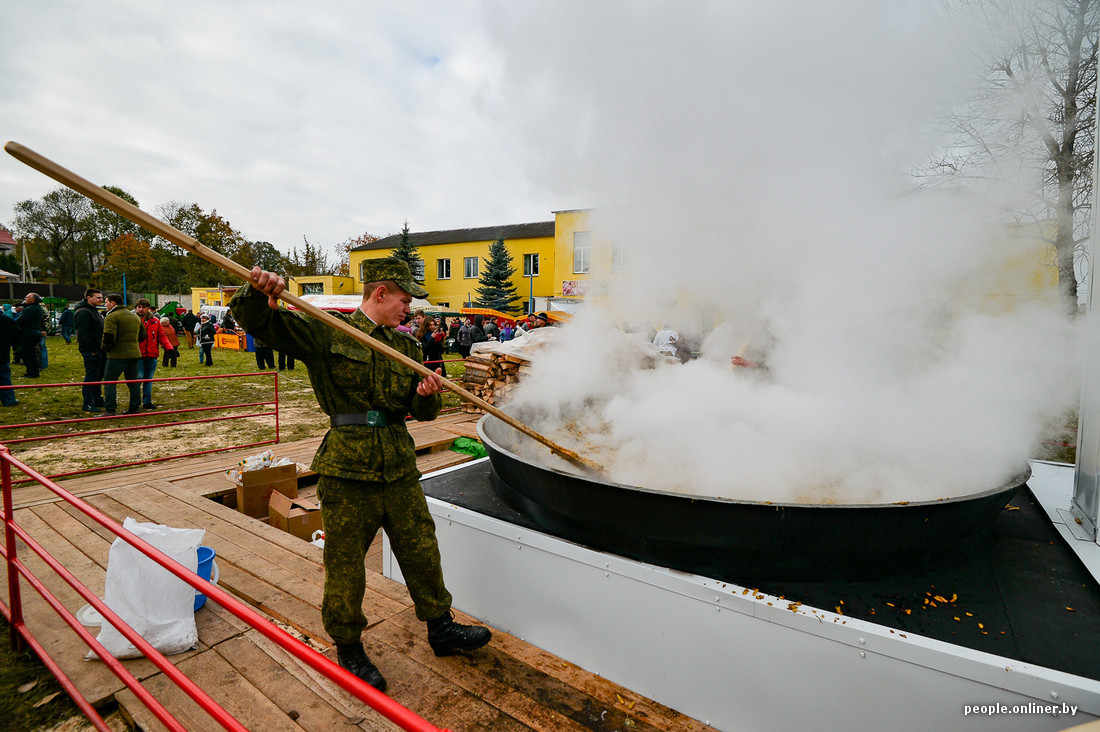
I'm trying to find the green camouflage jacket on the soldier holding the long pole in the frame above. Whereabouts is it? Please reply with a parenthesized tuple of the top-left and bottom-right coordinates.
(229, 285, 442, 482)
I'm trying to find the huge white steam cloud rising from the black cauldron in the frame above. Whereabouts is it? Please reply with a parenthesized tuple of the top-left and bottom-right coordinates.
(488, 0, 1078, 503)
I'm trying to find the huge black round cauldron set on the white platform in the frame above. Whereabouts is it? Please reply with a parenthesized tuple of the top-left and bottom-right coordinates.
(477, 414, 1031, 583)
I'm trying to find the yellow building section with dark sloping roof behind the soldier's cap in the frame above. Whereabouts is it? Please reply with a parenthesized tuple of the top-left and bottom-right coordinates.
(350, 221, 558, 313)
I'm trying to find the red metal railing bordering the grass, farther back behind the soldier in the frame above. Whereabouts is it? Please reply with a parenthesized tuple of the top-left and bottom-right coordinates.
(0, 371, 279, 484)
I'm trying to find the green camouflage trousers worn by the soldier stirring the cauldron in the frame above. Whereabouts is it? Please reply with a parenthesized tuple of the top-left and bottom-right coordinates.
(317, 476, 451, 643)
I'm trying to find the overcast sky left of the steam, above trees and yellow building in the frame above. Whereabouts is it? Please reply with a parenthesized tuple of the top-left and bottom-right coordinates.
(0, 0, 567, 258)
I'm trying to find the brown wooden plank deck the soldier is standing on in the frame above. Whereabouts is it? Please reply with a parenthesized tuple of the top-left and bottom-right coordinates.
(0, 415, 705, 732)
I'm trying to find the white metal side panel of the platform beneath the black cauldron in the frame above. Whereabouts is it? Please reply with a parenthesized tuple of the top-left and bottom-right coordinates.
(384, 498, 1100, 732)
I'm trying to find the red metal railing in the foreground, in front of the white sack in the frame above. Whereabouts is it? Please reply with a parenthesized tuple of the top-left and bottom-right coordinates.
(0, 445, 440, 732)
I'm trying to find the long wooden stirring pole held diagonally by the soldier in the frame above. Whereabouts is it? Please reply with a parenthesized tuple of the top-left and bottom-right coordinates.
(3, 142, 603, 473)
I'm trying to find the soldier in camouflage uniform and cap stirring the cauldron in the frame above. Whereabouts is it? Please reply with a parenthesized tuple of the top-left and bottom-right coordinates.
(230, 258, 492, 690)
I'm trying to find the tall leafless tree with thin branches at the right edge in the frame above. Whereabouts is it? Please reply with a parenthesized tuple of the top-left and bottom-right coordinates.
(922, 0, 1100, 312)
